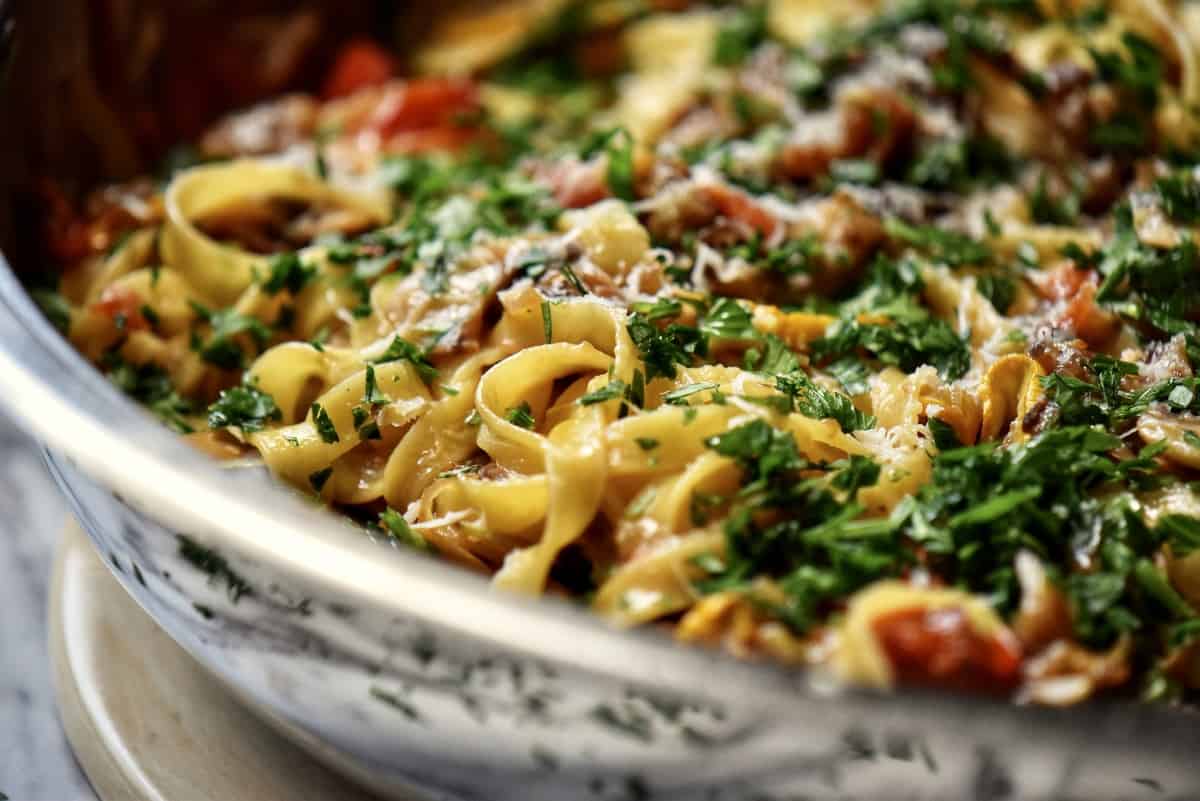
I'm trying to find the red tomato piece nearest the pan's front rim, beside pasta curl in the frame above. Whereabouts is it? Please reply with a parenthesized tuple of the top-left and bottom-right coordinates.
(875, 607, 1021, 693)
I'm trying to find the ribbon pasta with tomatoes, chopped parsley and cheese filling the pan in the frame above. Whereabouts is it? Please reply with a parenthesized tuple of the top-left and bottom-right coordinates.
(35, 0, 1200, 705)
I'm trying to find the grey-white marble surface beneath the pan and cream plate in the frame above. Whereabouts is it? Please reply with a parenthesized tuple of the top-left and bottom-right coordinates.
(0, 412, 95, 801)
